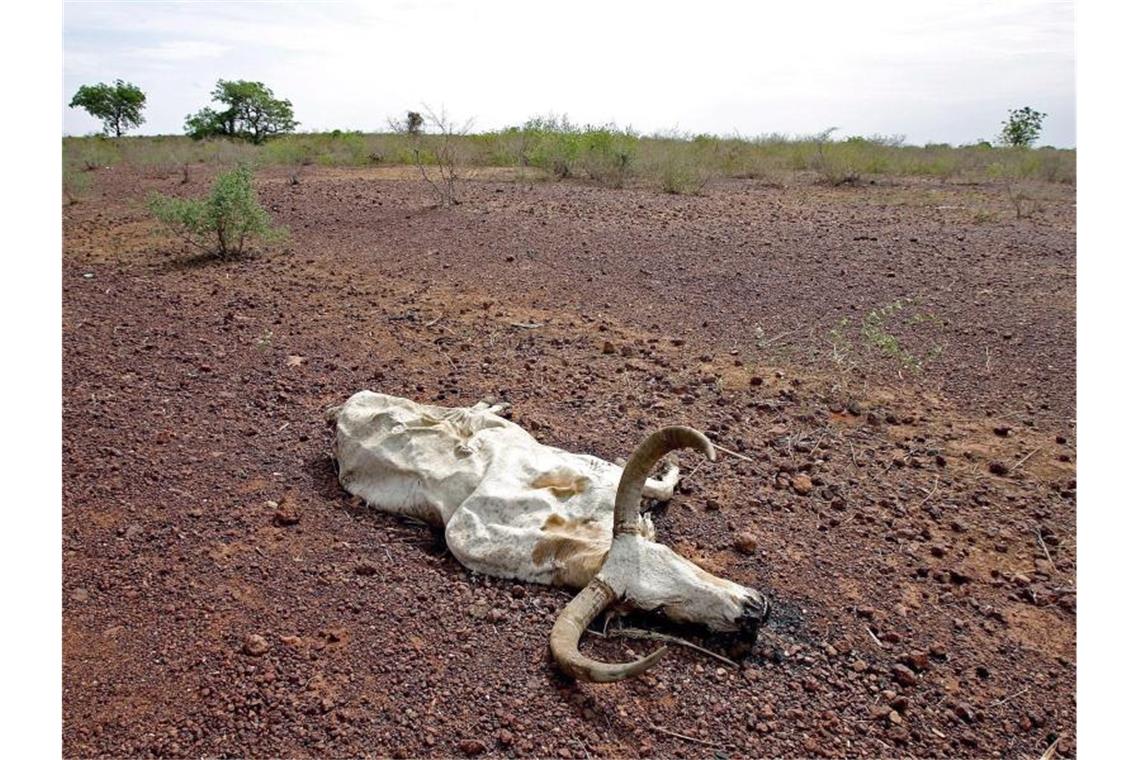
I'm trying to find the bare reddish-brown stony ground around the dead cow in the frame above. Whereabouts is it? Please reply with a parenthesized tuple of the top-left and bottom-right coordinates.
(63, 167, 1076, 758)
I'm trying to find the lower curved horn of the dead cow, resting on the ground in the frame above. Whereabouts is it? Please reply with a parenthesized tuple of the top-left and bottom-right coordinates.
(551, 575, 666, 684)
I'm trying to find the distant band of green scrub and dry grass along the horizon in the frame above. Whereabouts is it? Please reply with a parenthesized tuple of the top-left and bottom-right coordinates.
(64, 117, 1076, 193)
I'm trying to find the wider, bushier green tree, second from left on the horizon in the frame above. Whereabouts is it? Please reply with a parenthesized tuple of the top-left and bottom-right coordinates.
(186, 80, 298, 144)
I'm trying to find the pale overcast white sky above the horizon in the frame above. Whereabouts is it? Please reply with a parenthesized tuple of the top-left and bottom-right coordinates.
(62, 0, 1076, 147)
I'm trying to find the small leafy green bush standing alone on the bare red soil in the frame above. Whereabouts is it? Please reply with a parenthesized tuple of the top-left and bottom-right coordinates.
(148, 164, 288, 259)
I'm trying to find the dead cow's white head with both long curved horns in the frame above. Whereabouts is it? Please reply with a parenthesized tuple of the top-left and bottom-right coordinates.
(551, 426, 767, 681)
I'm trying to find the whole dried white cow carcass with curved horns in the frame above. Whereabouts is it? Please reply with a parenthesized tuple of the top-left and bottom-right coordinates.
(329, 391, 767, 681)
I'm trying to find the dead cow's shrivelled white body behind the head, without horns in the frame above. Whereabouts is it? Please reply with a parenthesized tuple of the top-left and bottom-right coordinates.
(336, 391, 676, 588)
